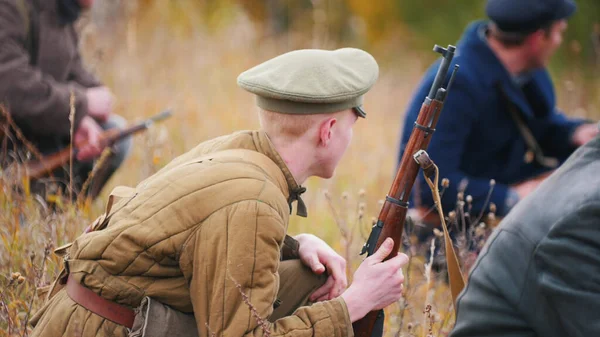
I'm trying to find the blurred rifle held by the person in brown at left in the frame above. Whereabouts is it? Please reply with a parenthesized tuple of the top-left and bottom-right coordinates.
(24, 110, 172, 180)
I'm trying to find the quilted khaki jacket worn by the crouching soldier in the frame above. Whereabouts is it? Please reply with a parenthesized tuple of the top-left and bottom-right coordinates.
(32, 131, 353, 337)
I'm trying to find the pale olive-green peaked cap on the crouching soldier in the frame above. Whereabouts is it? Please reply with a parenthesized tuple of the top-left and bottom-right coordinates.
(237, 48, 379, 117)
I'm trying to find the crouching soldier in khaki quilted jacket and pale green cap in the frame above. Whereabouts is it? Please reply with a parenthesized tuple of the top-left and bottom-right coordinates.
(32, 48, 408, 337)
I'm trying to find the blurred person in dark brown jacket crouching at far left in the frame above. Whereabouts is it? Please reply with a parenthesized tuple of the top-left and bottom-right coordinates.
(0, 0, 131, 198)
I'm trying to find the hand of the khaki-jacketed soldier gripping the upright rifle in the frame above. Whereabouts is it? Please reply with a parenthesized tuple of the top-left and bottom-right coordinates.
(342, 238, 408, 322)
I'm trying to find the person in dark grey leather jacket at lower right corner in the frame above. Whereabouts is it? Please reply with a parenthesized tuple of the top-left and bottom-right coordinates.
(450, 122, 600, 337)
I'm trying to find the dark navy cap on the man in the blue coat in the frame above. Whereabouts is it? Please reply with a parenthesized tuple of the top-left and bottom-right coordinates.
(485, 0, 577, 33)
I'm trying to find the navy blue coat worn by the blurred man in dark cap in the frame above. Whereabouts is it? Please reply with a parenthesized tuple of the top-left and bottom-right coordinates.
(400, 21, 584, 215)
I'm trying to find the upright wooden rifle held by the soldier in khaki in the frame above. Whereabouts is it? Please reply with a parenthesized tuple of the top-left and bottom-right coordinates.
(352, 45, 458, 337)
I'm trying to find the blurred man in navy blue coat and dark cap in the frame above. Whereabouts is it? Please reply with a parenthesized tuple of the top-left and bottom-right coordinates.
(400, 0, 598, 216)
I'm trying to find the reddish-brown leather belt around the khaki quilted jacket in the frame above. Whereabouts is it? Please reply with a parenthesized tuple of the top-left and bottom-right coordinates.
(67, 275, 135, 329)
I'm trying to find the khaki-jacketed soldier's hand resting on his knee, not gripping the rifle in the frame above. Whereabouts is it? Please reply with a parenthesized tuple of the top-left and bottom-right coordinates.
(294, 234, 348, 302)
